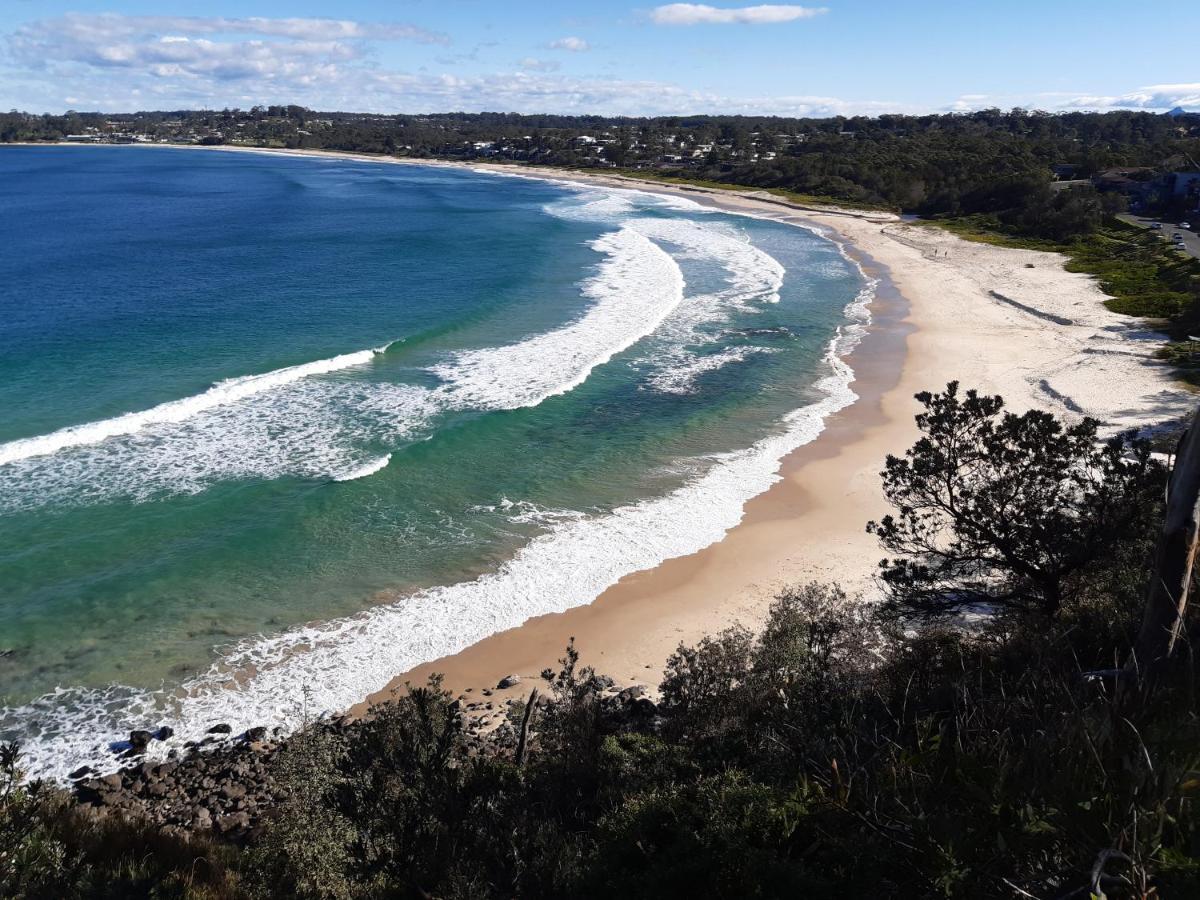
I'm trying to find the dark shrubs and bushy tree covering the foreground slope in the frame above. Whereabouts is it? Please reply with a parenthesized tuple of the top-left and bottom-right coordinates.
(0, 385, 1200, 900)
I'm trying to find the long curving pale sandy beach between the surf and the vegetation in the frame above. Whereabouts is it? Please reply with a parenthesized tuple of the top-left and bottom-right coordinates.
(11, 144, 1192, 753)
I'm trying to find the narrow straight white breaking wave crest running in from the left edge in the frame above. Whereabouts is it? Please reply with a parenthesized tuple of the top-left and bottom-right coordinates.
(0, 342, 395, 466)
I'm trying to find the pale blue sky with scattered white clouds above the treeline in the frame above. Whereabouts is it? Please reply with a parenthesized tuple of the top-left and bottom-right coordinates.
(0, 0, 1200, 116)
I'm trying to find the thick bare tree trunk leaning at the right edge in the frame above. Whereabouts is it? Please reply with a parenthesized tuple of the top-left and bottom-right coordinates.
(1129, 410, 1200, 688)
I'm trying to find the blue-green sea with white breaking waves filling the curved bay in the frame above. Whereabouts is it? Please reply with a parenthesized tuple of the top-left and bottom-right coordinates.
(0, 148, 869, 774)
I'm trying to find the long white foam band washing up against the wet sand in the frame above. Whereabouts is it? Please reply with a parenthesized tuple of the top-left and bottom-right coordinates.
(0, 259, 875, 779)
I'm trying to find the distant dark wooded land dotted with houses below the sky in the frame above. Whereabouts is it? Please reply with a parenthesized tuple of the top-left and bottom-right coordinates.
(7, 106, 1200, 226)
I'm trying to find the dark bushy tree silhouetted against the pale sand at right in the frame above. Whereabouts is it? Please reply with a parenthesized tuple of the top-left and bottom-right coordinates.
(868, 382, 1165, 618)
